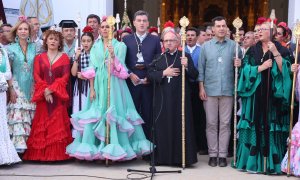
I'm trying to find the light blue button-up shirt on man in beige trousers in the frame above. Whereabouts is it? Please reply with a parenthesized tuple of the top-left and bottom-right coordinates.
(198, 38, 242, 96)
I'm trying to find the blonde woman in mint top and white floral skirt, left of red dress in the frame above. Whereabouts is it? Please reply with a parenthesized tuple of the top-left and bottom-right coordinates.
(7, 16, 38, 153)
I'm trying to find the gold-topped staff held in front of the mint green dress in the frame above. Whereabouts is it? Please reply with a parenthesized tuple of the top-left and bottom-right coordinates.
(105, 16, 116, 166)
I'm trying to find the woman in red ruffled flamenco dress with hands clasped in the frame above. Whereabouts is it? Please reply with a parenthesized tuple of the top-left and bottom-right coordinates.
(23, 30, 72, 161)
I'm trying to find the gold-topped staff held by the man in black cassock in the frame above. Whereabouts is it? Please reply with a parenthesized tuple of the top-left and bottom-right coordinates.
(179, 16, 190, 169)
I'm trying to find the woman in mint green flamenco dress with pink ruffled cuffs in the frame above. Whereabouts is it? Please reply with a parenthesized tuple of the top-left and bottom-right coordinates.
(67, 18, 152, 161)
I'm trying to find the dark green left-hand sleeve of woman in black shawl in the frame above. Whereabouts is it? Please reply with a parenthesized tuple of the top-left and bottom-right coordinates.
(237, 54, 261, 97)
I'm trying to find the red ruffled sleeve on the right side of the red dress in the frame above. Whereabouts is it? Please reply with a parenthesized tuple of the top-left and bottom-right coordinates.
(48, 54, 70, 101)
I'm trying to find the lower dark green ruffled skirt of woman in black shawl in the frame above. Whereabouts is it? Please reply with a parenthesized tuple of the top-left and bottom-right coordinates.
(236, 113, 289, 174)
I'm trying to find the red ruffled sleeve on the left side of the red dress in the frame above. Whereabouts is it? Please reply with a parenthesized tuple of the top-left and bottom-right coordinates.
(32, 54, 48, 102)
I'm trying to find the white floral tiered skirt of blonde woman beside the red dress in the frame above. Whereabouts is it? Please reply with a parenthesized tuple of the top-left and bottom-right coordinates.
(7, 80, 35, 153)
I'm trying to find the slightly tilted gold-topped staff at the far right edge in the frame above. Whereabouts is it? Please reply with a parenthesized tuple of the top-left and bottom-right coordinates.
(287, 23, 300, 176)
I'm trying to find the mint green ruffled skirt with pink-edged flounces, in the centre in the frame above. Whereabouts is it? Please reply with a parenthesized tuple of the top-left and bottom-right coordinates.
(67, 76, 152, 161)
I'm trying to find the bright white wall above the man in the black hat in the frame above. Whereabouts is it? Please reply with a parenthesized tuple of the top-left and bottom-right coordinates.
(52, 0, 113, 28)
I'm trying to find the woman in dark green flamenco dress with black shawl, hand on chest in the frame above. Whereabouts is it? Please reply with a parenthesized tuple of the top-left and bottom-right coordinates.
(236, 22, 291, 174)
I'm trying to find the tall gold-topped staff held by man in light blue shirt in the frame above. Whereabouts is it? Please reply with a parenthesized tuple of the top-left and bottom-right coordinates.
(232, 17, 243, 167)
